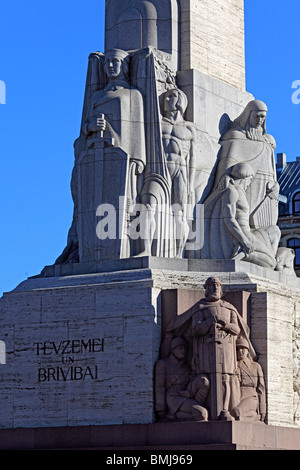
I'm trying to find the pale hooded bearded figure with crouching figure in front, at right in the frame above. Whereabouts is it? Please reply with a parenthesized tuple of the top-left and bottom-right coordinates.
(201, 100, 281, 269)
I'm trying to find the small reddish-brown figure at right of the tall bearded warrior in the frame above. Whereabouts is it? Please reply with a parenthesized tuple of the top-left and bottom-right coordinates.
(231, 338, 266, 421)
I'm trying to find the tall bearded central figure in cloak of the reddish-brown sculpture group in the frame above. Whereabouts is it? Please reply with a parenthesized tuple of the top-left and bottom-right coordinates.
(163, 276, 256, 420)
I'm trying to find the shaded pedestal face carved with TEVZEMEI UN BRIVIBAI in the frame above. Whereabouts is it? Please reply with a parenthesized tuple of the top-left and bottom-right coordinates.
(0, 272, 160, 428)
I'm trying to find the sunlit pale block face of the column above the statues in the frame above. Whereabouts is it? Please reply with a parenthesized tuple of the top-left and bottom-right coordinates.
(181, 0, 245, 91)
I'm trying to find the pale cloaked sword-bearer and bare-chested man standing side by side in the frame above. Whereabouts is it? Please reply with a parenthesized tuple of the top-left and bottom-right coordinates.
(56, 48, 204, 264)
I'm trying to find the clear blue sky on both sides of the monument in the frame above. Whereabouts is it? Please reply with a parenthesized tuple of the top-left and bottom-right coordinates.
(0, 0, 300, 296)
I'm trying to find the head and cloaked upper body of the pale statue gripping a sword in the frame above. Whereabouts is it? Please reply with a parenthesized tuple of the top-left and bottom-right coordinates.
(83, 49, 146, 203)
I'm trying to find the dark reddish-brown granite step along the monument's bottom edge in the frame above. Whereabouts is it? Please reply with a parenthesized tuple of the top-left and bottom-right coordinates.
(0, 421, 300, 455)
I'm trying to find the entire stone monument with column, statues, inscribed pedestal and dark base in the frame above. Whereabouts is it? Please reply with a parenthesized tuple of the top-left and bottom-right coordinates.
(0, 0, 300, 450)
